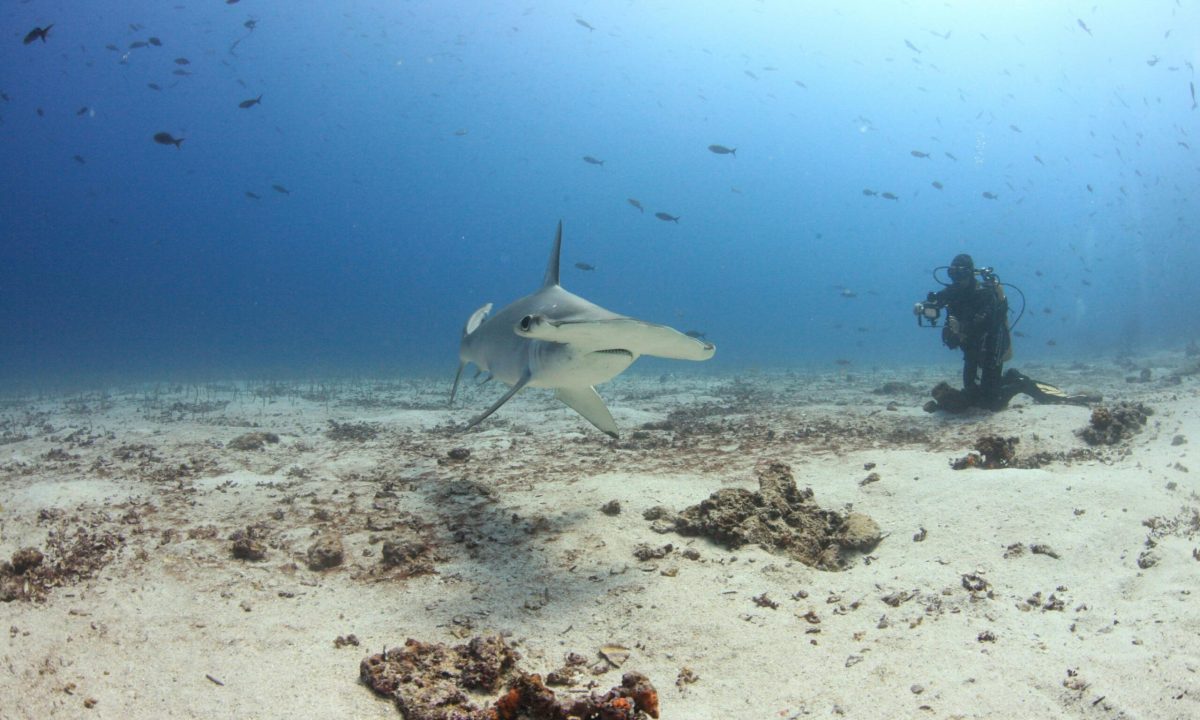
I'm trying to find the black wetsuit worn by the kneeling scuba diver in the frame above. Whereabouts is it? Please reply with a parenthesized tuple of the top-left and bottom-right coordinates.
(929, 277, 1013, 410)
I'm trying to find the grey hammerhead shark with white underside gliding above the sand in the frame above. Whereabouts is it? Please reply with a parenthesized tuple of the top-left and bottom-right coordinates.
(450, 221, 716, 438)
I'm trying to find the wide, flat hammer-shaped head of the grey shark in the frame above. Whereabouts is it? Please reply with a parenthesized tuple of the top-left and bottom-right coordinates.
(514, 316, 716, 360)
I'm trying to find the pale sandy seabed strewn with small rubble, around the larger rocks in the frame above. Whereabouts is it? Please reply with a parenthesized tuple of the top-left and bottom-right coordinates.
(0, 353, 1200, 720)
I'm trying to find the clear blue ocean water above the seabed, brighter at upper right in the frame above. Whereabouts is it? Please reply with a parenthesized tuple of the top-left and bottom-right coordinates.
(0, 0, 1200, 384)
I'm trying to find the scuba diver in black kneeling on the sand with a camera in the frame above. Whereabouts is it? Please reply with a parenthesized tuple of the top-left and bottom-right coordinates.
(913, 253, 1099, 413)
